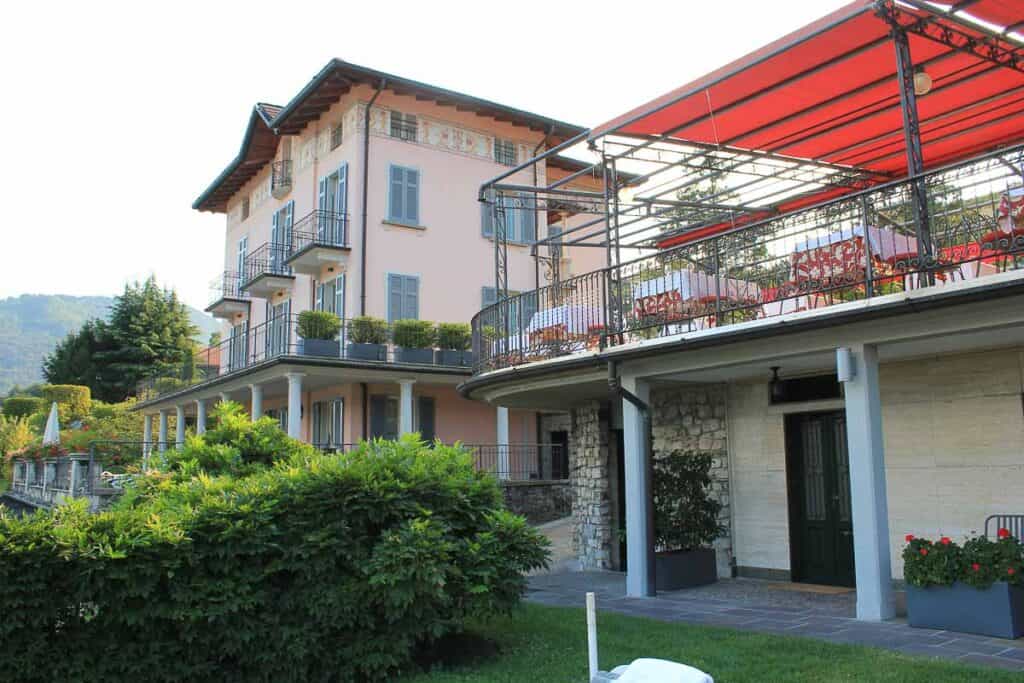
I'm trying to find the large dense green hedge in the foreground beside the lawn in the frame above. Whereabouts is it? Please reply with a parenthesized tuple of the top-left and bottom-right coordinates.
(0, 438, 546, 683)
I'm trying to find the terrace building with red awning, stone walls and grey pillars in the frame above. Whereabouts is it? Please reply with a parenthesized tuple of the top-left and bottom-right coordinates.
(461, 0, 1024, 620)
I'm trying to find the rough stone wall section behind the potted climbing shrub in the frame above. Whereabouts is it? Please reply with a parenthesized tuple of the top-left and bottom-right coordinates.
(650, 384, 732, 577)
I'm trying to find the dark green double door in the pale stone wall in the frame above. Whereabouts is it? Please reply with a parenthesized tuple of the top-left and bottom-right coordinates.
(785, 412, 854, 586)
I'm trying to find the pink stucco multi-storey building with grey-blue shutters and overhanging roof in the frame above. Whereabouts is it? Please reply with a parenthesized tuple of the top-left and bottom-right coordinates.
(132, 59, 603, 476)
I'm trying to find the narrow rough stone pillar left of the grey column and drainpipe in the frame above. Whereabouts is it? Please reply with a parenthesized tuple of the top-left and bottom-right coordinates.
(569, 401, 612, 569)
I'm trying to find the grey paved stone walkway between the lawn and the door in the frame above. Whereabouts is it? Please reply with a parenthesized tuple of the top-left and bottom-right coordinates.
(526, 571, 1024, 672)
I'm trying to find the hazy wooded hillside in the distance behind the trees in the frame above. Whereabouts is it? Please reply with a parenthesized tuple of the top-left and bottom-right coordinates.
(0, 294, 220, 395)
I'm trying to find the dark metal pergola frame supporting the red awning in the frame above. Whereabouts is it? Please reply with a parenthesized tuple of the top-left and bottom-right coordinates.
(478, 0, 1024, 309)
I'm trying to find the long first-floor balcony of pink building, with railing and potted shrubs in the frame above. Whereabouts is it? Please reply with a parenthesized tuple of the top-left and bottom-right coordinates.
(136, 315, 473, 400)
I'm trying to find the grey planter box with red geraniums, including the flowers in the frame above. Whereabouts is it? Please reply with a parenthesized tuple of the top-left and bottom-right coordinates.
(903, 528, 1024, 639)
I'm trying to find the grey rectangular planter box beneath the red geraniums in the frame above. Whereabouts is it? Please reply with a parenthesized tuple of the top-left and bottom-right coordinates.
(906, 582, 1024, 639)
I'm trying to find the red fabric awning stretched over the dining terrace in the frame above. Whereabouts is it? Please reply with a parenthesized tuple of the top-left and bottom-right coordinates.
(591, 0, 1024, 248)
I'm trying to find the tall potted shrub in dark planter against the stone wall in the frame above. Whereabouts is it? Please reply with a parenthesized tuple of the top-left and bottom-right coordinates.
(652, 451, 724, 591)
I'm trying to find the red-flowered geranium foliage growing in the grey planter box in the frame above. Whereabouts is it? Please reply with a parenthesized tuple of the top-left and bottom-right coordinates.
(903, 528, 1024, 588)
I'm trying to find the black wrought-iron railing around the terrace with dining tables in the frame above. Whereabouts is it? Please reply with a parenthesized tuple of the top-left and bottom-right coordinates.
(472, 146, 1024, 373)
